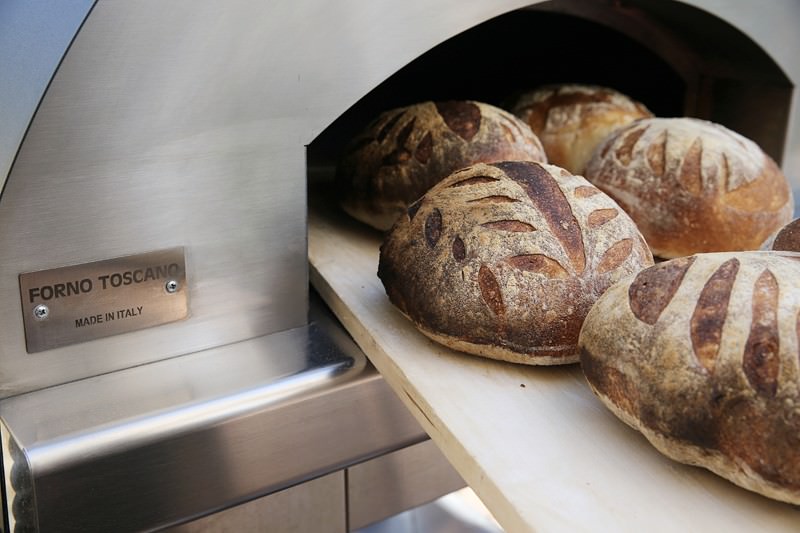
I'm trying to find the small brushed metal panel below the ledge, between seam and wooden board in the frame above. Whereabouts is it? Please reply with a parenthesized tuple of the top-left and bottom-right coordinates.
(347, 440, 466, 529)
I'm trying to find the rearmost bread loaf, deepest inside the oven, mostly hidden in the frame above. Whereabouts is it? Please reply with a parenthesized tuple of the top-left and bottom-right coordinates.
(512, 84, 653, 174)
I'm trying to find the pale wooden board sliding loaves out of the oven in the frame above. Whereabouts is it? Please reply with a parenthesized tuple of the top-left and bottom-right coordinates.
(308, 205, 800, 533)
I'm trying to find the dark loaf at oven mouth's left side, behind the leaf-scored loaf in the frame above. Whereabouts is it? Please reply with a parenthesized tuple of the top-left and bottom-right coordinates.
(337, 101, 546, 230)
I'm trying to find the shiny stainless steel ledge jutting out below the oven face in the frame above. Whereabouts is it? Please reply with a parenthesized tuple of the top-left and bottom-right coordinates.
(0, 304, 425, 532)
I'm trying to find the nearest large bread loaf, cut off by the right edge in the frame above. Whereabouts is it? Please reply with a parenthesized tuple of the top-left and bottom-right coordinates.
(579, 252, 800, 504)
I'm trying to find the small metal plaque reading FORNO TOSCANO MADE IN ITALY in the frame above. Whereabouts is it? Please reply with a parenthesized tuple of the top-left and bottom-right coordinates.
(19, 247, 188, 353)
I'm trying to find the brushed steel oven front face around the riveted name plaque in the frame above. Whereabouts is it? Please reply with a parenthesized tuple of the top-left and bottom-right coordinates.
(0, 0, 527, 397)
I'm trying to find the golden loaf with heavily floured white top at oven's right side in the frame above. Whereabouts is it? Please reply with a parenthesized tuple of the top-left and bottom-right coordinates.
(585, 118, 794, 258)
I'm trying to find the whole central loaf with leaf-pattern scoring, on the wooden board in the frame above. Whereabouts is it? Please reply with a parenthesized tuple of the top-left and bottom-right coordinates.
(378, 161, 652, 365)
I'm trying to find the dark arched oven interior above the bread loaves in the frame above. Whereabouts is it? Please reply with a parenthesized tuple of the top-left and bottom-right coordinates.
(308, 0, 793, 178)
